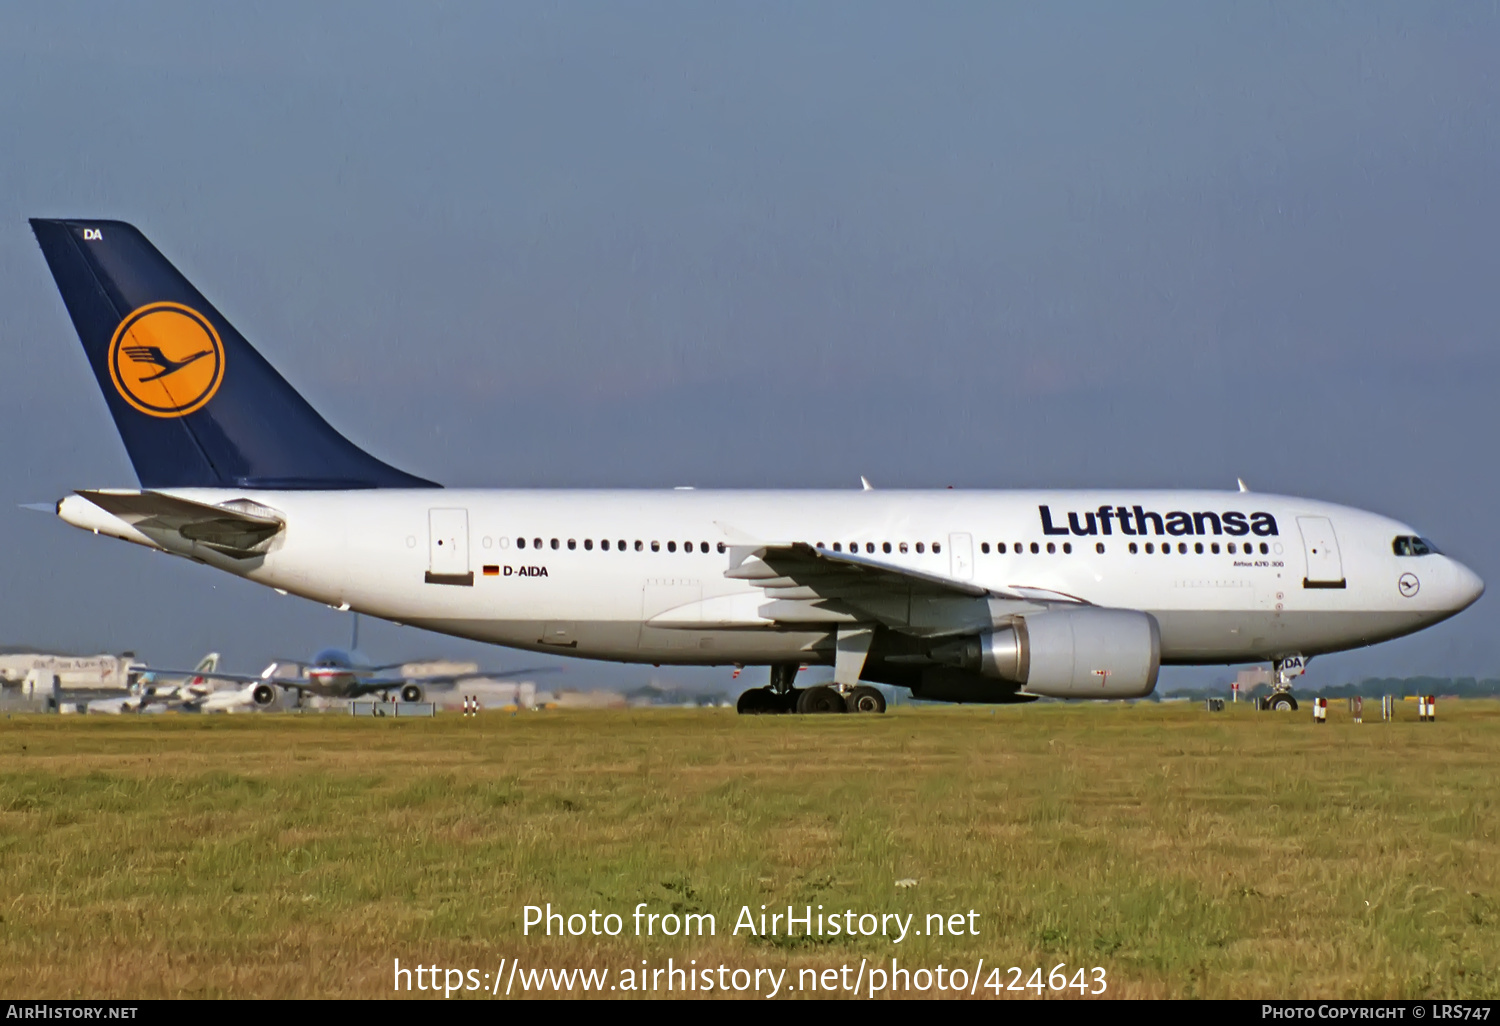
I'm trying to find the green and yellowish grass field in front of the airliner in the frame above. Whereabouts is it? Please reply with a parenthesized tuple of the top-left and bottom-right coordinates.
(0, 701, 1500, 998)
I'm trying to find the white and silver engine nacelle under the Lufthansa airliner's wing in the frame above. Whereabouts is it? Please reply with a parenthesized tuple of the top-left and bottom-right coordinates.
(933, 606, 1161, 699)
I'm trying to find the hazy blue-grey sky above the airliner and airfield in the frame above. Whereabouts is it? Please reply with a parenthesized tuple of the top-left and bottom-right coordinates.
(0, 0, 1500, 687)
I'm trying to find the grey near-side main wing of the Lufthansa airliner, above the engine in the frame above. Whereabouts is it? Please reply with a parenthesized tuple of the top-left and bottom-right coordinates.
(725, 542, 1077, 636)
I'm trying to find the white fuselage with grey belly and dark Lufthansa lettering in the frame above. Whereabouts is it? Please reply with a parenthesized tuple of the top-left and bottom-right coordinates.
(60, 489, 1484, 665)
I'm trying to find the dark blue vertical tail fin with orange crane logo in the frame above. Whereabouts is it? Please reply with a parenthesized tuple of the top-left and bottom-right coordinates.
(32, 218, 437, 489)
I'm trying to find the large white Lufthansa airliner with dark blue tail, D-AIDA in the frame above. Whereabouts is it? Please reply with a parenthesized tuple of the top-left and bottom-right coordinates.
(32, 219, 1484, 713)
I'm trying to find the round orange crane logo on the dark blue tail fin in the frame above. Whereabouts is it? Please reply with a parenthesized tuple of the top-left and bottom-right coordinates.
(110, 303, 224, 417)
